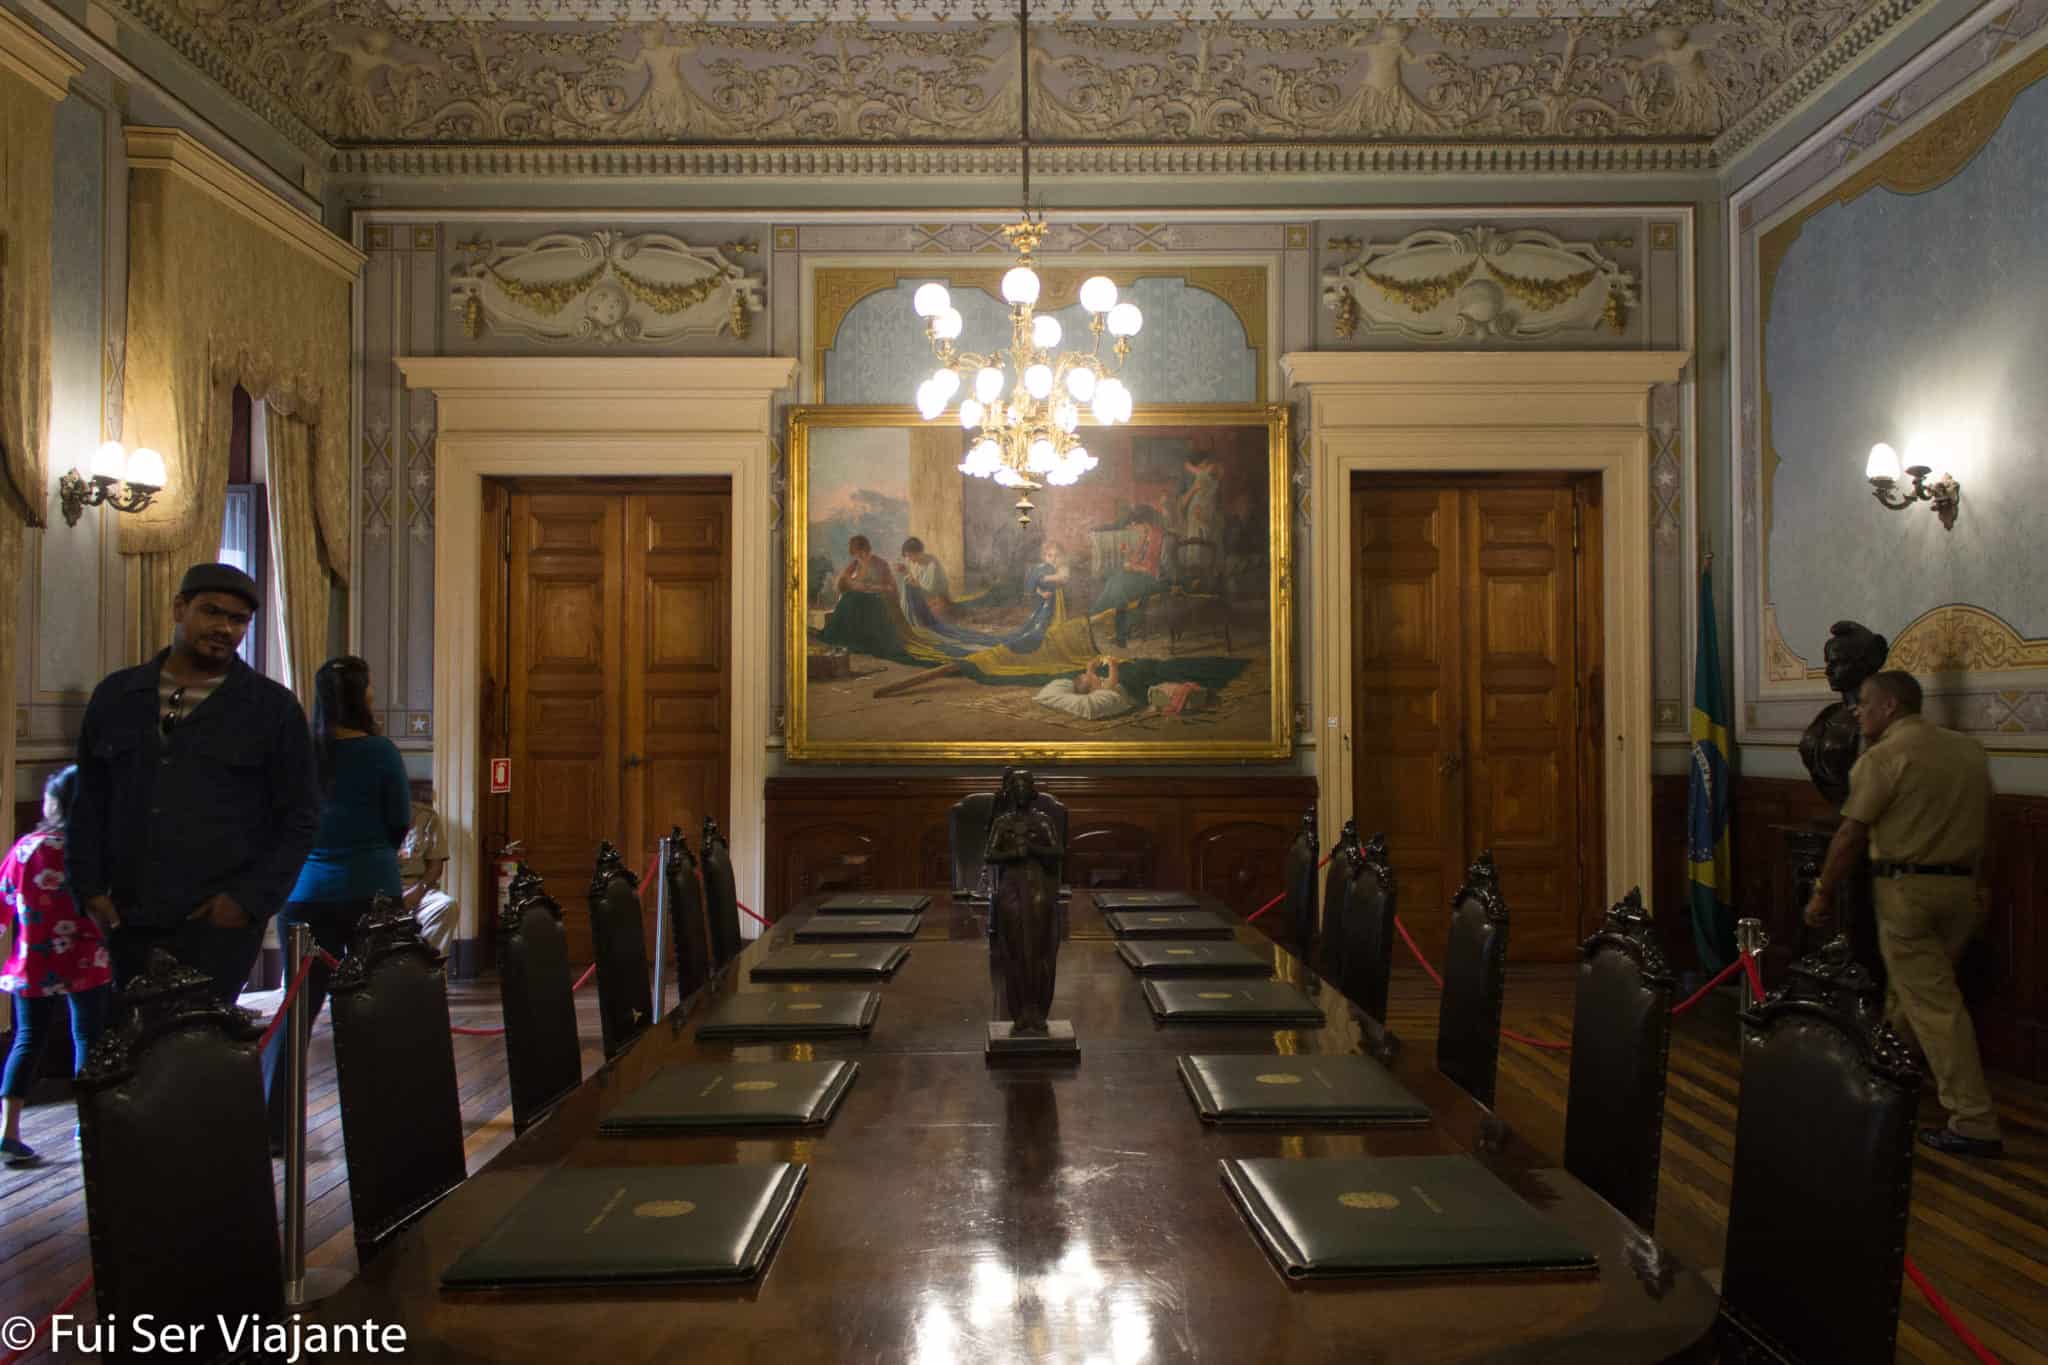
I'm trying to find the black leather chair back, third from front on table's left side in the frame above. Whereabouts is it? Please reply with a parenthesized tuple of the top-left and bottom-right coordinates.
(498, 864, 584, 1132)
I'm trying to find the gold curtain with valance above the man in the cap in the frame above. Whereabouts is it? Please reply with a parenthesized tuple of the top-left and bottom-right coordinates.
(121, 129, 360, 663)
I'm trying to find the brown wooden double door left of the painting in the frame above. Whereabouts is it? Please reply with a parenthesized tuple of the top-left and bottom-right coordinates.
(499, 481, 731, 960)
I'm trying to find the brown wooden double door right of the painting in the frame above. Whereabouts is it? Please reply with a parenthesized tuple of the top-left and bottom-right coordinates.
(1352, 477, 1602, 962)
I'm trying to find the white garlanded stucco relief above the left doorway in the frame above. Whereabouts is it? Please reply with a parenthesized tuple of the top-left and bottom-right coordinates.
(449, 229, 764, 346)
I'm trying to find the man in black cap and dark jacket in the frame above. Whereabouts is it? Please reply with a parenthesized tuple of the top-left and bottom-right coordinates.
(68, 565, 319, 1003)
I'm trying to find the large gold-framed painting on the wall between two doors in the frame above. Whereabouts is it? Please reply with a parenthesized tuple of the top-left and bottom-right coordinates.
(786, 405, 1292, 763)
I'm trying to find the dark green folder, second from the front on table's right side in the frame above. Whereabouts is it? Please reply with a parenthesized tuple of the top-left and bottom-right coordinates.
(1180, 1054, 1430, 1126)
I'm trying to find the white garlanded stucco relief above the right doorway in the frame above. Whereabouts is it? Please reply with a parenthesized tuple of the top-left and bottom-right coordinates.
(1323, 225, 1636, 342)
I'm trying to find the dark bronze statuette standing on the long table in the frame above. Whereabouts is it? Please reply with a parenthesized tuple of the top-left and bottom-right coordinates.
(985, 767, 1081, 1060)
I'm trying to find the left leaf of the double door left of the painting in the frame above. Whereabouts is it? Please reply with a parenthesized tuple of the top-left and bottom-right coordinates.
(510, 493, 623, 960)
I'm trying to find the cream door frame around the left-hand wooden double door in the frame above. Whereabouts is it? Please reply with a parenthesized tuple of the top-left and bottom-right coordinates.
(397, 356, 797, 939)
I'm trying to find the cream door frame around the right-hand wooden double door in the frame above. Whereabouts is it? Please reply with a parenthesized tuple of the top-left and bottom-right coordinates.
(1280, 350, 1692, 902)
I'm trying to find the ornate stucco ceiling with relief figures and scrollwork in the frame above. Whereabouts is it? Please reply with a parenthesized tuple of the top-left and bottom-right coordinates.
(99, 0, 1921, 170)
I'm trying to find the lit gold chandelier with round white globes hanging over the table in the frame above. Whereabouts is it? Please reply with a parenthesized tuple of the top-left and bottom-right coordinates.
(911, 6, 1145, 526)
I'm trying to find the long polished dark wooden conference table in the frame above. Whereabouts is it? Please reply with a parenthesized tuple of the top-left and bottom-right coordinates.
(307, 892, 1716, 1365)
